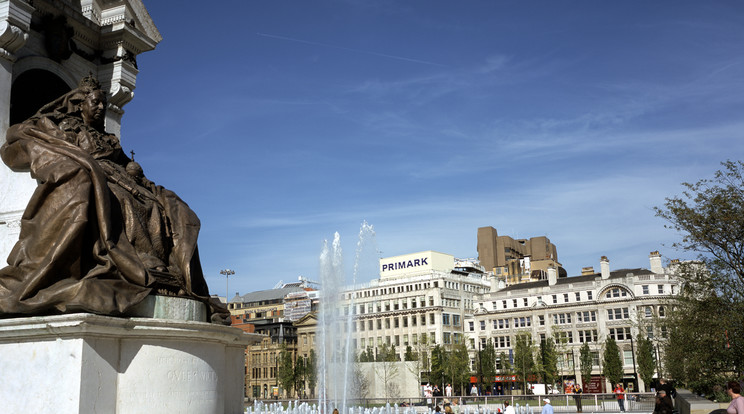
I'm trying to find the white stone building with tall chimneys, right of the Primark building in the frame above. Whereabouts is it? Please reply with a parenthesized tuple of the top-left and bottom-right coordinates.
(465, 252, 679, 391)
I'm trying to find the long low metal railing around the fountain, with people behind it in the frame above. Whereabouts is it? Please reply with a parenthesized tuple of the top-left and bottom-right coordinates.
(246, 393, 655, 414)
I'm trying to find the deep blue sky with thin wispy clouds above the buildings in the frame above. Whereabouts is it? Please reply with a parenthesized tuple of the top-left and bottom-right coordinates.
(122, 0, 744, 296)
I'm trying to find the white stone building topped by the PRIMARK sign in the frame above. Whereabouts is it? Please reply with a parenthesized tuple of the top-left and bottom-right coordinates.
(342, 251, 491, 360)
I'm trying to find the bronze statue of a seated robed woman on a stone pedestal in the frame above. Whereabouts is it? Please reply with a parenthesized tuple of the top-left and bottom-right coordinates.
(0, 76, 229, 322)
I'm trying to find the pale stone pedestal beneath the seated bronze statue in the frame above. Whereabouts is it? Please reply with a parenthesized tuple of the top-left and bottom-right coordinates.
(0, 313, 260, 414)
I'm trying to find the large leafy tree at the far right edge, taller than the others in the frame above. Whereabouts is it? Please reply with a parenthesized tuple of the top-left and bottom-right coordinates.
(655, 161, 744, 394)
